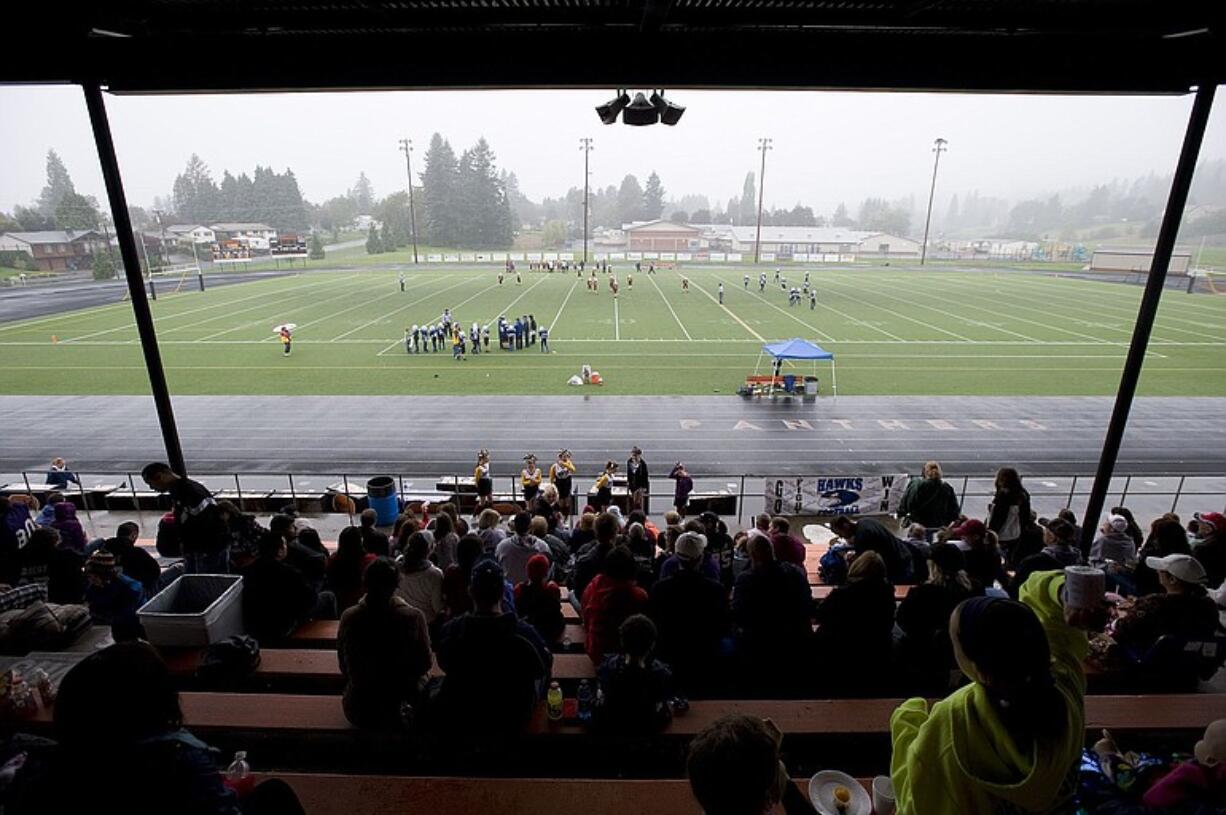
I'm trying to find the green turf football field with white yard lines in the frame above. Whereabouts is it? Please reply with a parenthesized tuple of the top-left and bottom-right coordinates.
(0, 263, 1226, 396)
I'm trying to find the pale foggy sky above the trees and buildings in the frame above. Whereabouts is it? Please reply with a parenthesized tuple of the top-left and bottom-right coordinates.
(0, 87, 1226, 214)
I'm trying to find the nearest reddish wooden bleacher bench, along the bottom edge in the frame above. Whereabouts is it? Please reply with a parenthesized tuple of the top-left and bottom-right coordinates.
(257, 772, 870, 815)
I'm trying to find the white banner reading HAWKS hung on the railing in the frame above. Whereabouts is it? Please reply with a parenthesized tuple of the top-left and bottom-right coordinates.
(763, 473, 907, 517)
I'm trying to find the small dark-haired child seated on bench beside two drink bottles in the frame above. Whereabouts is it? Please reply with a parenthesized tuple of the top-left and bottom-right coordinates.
(596, 614, 673, 735)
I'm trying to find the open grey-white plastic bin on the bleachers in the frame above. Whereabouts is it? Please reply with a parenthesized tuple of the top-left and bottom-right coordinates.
(139, 575, 243, 647)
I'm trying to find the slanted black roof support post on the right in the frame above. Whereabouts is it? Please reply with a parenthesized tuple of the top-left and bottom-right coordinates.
(1081, 82, 1215, 550)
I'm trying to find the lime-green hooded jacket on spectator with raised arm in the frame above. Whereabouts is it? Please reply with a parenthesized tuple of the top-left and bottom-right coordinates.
(890, 572, 1089, 815)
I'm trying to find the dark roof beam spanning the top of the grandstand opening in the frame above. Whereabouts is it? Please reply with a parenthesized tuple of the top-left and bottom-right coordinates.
(16, 27, 1206, 93)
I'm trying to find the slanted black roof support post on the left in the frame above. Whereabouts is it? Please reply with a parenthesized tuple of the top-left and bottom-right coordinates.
(81, 82, 188, 476)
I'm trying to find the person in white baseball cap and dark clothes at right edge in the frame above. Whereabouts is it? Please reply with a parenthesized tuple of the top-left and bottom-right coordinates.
(1113, 555, 1217, 657)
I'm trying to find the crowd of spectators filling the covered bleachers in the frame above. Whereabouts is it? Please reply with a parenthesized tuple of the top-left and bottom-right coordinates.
(0, 462, 1226, 813)
